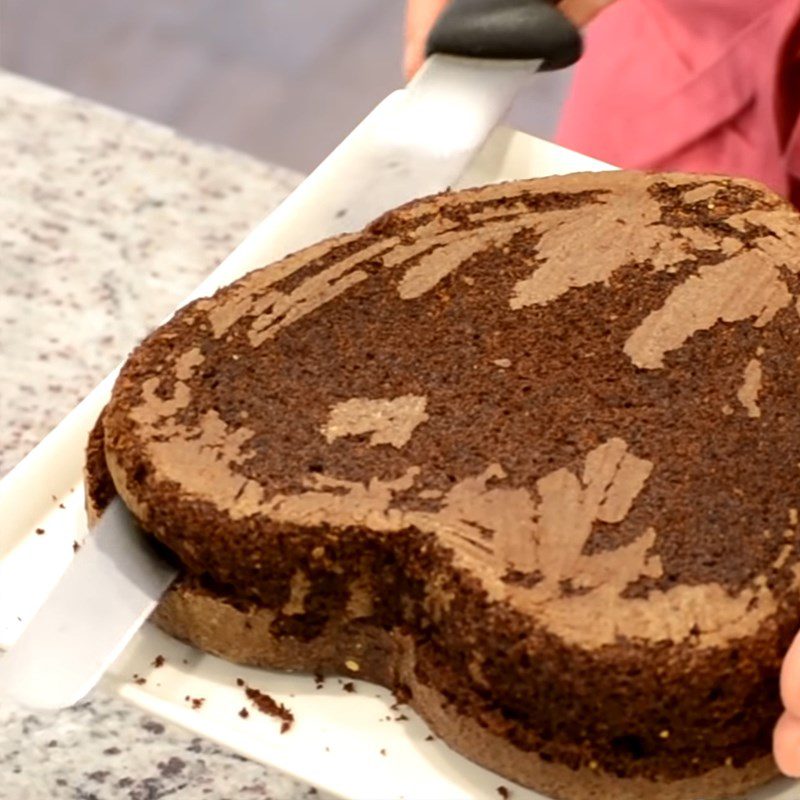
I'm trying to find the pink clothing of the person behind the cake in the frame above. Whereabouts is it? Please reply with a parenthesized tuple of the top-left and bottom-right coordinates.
(557, 0, 800, 199)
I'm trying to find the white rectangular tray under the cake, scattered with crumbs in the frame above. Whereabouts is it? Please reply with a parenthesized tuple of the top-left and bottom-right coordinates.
(0, 93, 797, 800)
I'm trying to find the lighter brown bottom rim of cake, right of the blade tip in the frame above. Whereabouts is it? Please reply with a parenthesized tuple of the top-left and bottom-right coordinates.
(153, 582, 778, 800)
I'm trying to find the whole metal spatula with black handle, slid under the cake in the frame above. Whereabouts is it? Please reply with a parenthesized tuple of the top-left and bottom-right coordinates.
(0, 0, 581, 708)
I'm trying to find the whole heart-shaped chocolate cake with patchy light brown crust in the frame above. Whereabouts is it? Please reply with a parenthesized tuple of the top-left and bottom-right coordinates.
(88, 172, 800, 800)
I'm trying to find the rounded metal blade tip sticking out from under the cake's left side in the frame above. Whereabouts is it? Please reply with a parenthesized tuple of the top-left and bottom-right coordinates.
(0, 498, 177, 709)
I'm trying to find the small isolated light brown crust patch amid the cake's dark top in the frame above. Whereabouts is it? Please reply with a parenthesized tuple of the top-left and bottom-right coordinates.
(321, 394, 429, 450)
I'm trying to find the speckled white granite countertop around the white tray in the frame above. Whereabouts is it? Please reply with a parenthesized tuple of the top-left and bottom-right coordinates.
(0, 72, 332, 800)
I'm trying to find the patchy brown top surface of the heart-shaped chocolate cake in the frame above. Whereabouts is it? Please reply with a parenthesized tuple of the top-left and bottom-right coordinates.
(105, 172, 800, 647)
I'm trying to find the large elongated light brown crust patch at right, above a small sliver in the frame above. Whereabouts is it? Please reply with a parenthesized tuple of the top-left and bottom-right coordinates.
(624, 250, 792, 369)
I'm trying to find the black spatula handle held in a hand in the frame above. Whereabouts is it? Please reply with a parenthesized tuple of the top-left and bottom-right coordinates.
(426, 0, 582, 69)
